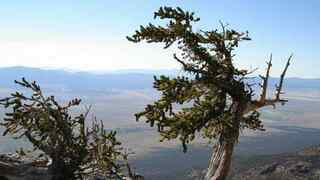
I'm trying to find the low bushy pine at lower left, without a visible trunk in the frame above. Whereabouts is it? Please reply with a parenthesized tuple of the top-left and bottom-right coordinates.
(0, 78, 132, 180)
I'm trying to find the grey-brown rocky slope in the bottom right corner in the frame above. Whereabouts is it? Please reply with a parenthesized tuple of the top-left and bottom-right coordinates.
(233, 146, 320, 180)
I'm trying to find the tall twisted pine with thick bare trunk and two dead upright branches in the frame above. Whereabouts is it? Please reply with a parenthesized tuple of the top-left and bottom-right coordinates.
(127, 7, 292, 180)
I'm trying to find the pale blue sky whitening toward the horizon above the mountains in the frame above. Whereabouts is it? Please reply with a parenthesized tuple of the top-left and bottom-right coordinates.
(0, 0, 320, 78)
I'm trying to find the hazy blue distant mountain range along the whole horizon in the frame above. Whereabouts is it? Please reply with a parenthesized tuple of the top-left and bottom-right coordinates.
(0, 66, 320, 91)
